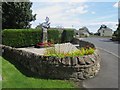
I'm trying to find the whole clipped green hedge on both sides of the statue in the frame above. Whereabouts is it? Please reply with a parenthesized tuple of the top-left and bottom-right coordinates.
(2, 28, 74, 47)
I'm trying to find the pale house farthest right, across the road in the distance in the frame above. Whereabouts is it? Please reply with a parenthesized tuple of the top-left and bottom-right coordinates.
(98, 25, 113, 36)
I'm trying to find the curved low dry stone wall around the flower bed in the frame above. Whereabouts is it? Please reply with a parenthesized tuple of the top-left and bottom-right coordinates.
(1, 45, 100, 80)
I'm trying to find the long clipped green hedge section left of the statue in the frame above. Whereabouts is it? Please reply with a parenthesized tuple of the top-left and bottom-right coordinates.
(2, 29, 42, 47)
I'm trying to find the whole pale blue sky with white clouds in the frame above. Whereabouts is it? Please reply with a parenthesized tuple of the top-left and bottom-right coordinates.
(30, 0, 120, 33)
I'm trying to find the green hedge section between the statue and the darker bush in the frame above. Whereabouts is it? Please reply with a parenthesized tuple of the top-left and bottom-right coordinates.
(48, 28, 61, 43)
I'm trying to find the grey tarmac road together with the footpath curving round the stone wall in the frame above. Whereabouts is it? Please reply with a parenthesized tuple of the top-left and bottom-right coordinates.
(83, 38, 120, 90)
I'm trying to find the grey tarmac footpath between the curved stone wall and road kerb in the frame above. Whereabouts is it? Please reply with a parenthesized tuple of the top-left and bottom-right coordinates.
(83, 50, 118, 88)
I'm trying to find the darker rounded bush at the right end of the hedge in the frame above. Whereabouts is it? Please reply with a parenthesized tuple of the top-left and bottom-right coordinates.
(61, 29, 74, 43)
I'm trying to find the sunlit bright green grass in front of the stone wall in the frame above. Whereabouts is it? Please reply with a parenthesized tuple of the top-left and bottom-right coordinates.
(0, 57, 75, 88)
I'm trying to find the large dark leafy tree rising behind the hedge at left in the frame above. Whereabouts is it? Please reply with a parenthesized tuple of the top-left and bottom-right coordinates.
(2, 2, 36, 29)
